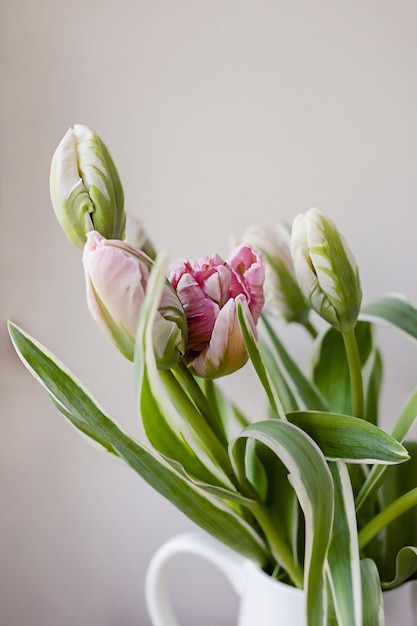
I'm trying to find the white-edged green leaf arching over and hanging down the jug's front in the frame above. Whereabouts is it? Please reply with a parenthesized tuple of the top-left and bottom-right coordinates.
(231, 419, 334, 626)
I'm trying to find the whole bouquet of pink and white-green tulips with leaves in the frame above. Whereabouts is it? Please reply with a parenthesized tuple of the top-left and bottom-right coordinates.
(9, 125, 417, 626)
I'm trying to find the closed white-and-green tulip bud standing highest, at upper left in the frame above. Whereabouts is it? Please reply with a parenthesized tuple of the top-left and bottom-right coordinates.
(50, 124, 126, 248)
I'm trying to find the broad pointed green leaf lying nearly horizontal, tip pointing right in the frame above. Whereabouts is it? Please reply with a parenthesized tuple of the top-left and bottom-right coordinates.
(287, 411, 409, 464)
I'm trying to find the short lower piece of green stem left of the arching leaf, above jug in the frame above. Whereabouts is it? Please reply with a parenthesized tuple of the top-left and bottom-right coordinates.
(249, 501, 304, 589)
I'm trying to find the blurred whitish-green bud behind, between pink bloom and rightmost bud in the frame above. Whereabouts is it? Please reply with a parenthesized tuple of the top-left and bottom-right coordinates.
(242, 224, 310, 323)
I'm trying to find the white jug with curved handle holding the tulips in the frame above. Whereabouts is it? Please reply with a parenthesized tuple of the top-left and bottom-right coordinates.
(146, 534, 417, 626)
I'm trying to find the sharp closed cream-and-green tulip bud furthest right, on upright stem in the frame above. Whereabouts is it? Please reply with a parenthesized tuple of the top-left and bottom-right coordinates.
(291, 209, 362, 332)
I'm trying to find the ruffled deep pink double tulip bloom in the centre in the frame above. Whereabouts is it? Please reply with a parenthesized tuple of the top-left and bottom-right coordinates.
(168, 245, 265, 378)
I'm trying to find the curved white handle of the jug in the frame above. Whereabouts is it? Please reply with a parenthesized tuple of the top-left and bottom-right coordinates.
(145, 533, 246, 626)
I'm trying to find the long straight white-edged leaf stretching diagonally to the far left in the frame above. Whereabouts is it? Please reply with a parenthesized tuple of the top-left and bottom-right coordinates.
(9, 323, 268, 566)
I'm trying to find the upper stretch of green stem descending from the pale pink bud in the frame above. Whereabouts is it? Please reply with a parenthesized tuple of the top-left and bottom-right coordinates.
(160, 370, 236, 486)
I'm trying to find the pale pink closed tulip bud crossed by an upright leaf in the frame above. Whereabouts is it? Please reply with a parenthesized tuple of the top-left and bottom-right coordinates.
(83, 231, 187, 369)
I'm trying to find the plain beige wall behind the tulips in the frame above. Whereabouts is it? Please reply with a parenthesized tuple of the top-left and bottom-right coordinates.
(0, 0, 417, 626)
